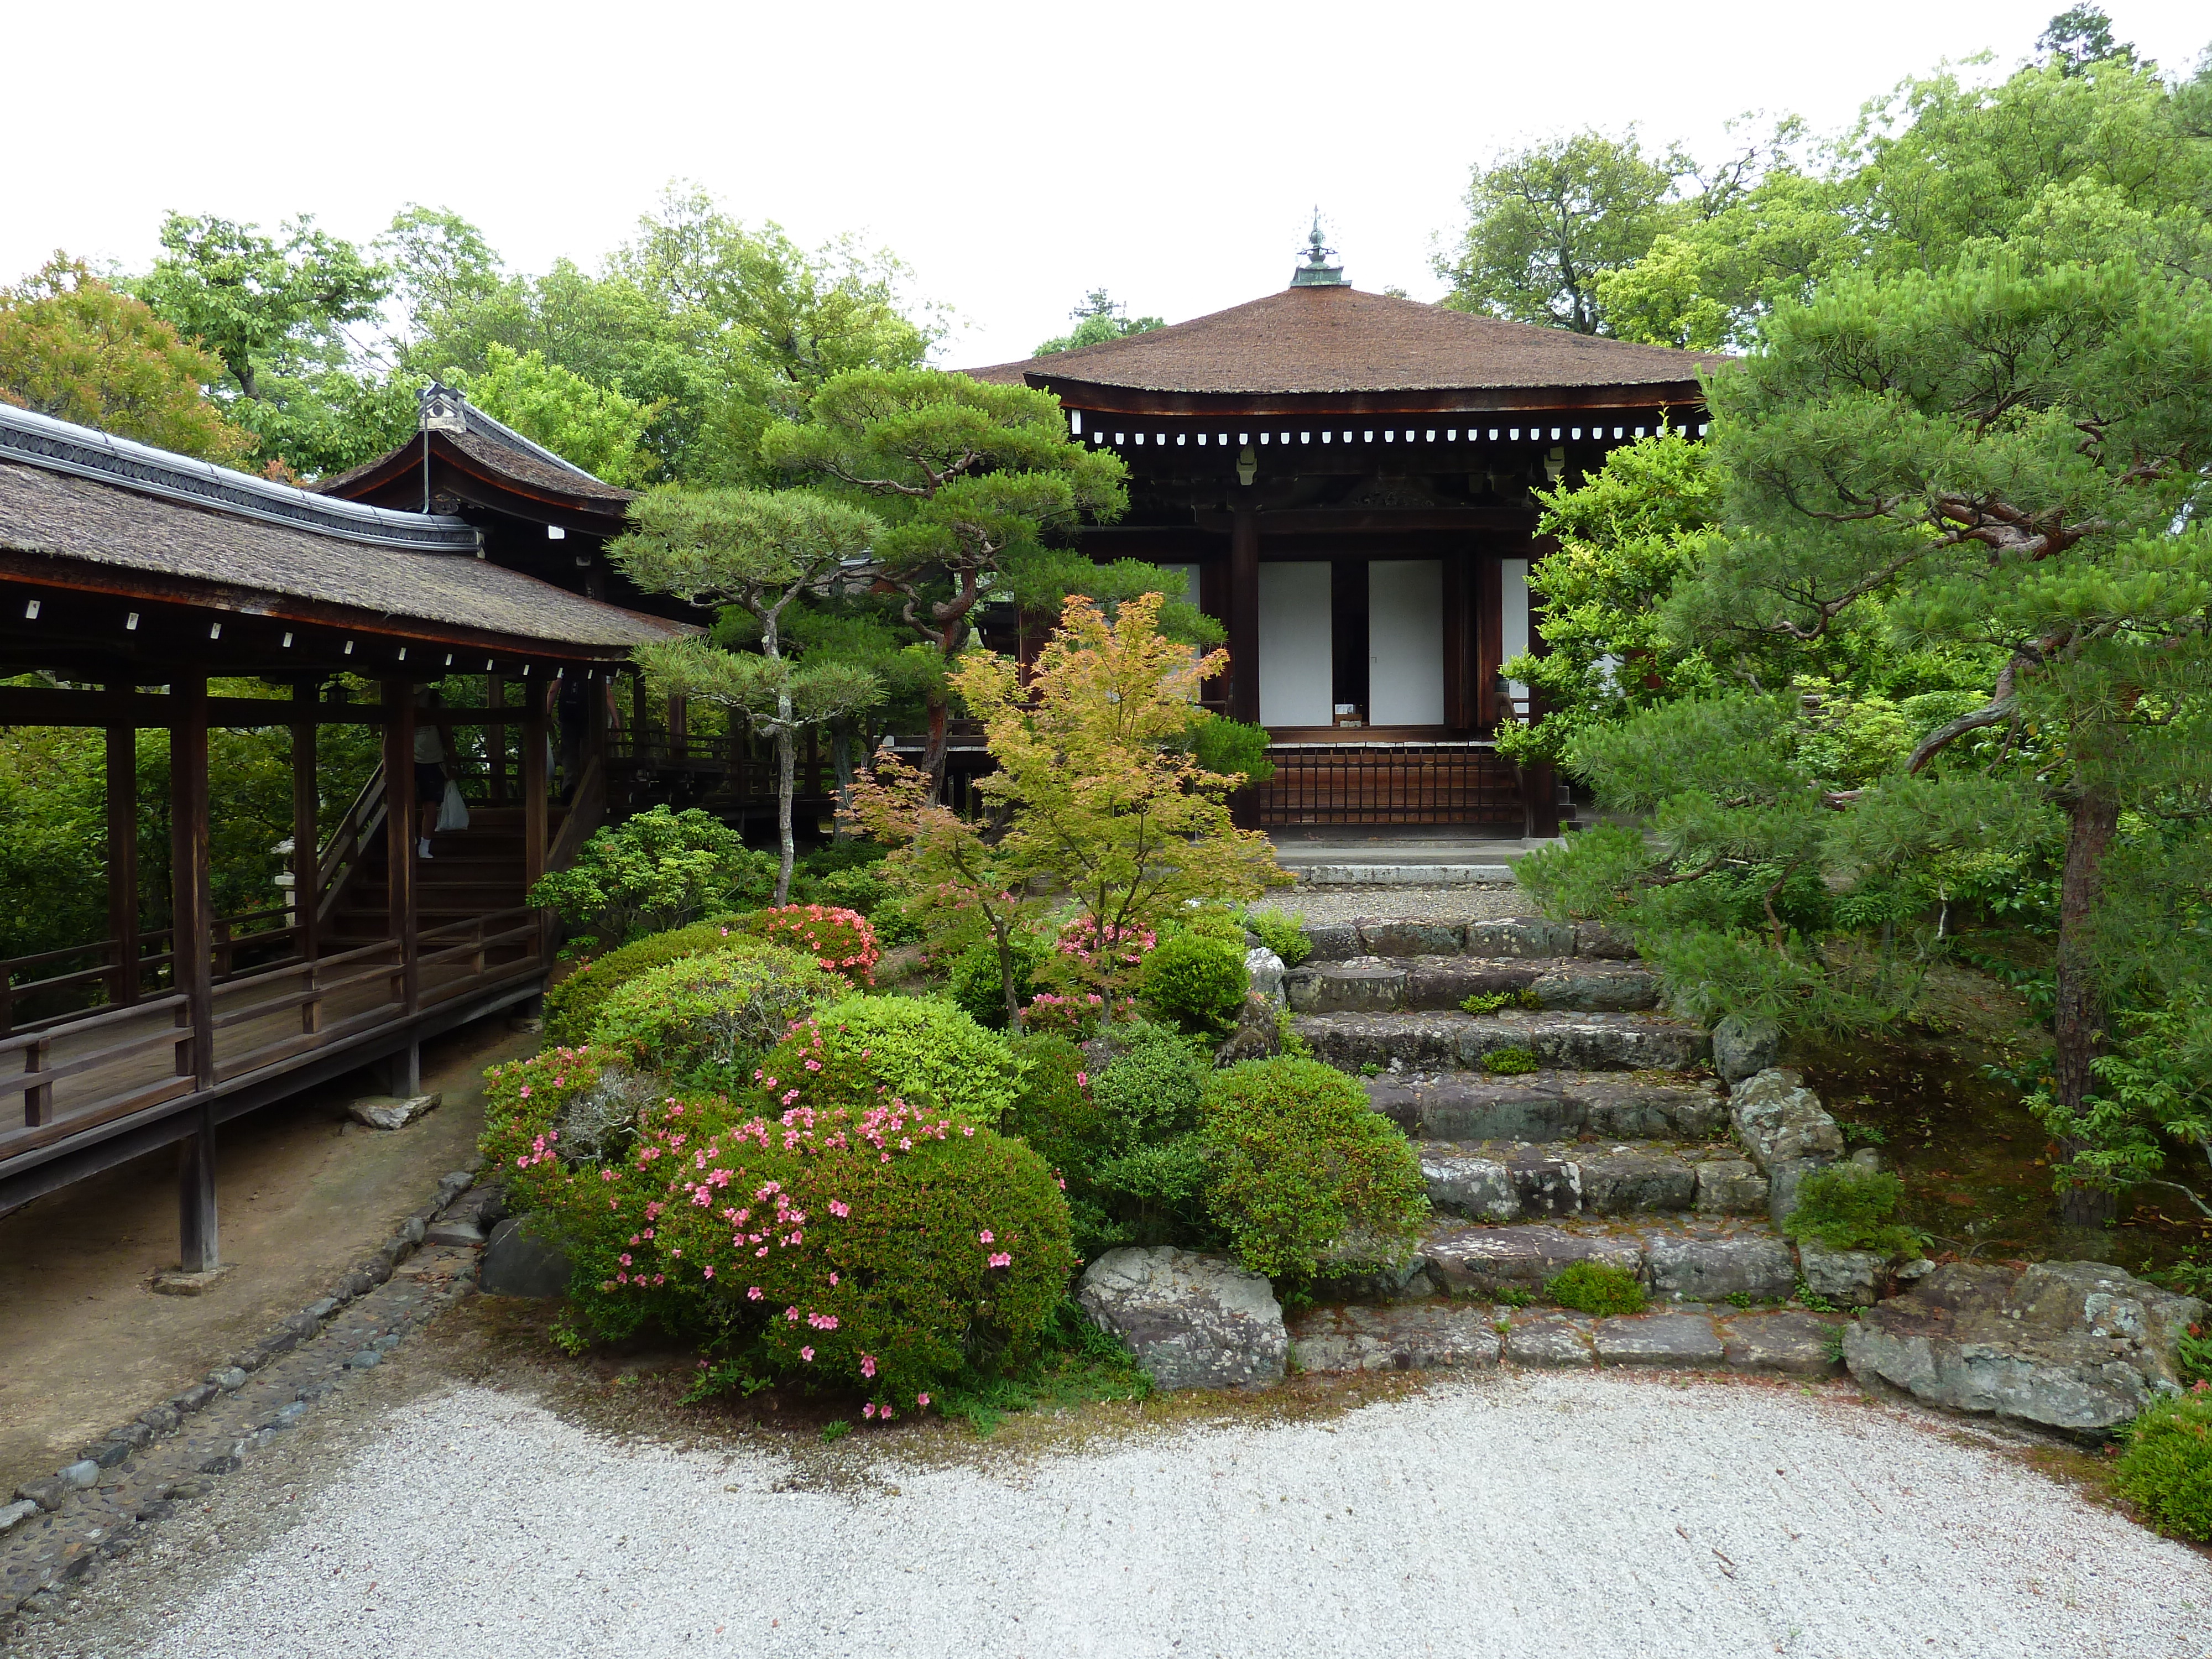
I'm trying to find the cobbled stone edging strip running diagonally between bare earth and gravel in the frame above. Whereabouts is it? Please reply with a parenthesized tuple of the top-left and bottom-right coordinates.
(0, 1166, 500, 1635)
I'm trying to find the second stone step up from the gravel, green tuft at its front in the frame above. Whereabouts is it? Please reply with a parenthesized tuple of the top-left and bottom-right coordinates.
(1420, 1223, 1798, 1303)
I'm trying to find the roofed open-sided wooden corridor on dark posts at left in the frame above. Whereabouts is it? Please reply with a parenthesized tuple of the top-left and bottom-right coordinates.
(0, 389, 692, 1272)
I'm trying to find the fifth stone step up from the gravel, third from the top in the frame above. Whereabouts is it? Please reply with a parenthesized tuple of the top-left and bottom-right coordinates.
(1292, 1009, 1712, 1073)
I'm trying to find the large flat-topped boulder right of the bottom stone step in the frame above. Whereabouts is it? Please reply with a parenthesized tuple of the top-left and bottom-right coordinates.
(1843, 1261, 2205, 1438)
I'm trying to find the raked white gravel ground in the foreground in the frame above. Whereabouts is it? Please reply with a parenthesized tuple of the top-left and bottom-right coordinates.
(126, 1374, 2212, 1659)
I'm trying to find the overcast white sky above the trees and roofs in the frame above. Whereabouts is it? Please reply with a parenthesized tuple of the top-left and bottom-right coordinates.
(0, 0, 2212, 365)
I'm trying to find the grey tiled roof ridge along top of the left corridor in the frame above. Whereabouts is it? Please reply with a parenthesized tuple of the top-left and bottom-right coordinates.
(0, 403, 484, 555)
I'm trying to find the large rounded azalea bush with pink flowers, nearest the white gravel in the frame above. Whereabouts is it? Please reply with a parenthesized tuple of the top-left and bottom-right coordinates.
(484, 1051, 1073, 1418)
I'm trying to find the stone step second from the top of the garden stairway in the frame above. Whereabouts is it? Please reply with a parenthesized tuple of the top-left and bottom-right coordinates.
(1283, 956, 1659, 1013)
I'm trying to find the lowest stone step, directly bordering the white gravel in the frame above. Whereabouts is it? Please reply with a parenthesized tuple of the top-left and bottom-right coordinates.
(1287, 1301, 1845, 1376)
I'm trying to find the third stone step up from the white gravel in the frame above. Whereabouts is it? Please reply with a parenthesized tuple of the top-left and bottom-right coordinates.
(1420, 1141, 1767, 1223)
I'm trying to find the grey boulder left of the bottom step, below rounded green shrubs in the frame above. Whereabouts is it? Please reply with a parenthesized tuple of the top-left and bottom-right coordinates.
(1075, 1245, 1290, 1389)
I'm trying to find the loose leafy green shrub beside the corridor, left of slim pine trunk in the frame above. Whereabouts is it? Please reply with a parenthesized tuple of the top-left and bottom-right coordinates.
(529, 807, 770, 947)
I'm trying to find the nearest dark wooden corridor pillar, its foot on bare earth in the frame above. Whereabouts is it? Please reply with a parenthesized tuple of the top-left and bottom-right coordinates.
(168, 675, 221, 1272)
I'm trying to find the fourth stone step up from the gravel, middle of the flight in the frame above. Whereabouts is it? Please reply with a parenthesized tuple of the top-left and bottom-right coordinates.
(1367, 1071, 1730, 1141)
